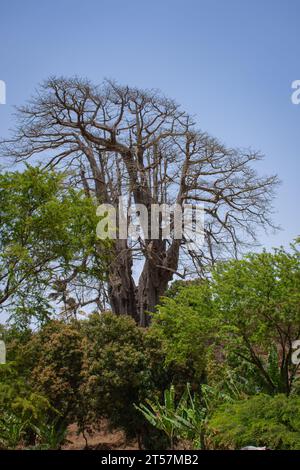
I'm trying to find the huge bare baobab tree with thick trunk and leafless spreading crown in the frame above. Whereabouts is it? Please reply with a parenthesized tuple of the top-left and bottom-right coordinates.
(1, 78, 277, 325)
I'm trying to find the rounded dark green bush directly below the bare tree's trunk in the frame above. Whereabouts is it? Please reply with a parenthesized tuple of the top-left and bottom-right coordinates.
(82, 313, 158, 437)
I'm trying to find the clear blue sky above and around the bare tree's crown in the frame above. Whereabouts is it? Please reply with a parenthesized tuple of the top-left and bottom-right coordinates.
(0, 0, 300, 248)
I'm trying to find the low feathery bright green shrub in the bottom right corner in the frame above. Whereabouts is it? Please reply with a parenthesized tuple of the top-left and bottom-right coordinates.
(208, 394, 300, 450)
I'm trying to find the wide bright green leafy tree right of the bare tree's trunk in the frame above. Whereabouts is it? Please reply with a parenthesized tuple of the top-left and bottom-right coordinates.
(155, 246, 300, 394)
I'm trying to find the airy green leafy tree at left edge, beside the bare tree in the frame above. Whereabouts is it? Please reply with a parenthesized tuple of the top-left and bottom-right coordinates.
(0, 166, 108, 327)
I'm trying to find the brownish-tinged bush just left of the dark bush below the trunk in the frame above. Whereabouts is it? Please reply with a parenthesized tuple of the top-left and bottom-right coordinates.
(20, 321, 84, 422)
